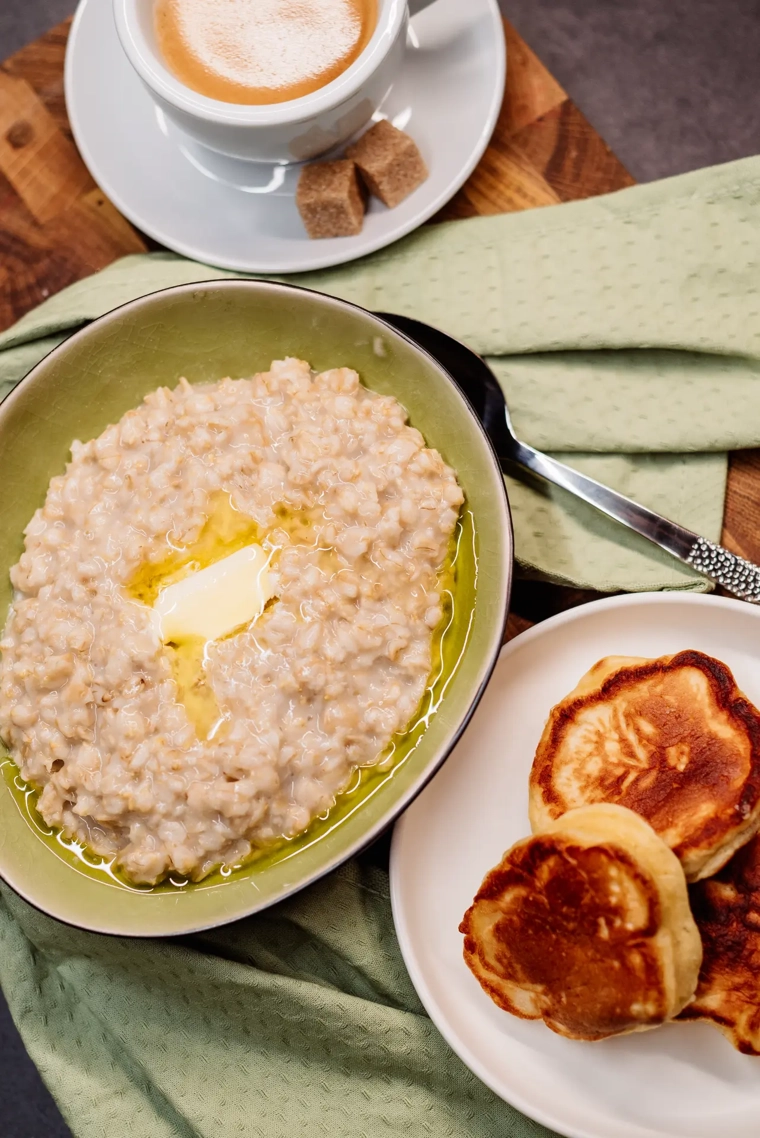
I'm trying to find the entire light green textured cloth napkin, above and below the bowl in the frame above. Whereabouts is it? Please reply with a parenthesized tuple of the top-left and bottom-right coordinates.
(0, 158, 760, 1138)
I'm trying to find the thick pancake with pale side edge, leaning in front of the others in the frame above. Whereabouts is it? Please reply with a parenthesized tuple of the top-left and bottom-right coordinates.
(460, 805, 702, 1039)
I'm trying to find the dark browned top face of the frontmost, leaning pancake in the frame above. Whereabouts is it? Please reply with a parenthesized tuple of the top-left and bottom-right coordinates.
(460, 834, 667, 1039)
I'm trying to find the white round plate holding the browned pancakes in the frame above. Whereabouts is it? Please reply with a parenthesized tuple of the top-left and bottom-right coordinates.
(390, 593, 760, 1138)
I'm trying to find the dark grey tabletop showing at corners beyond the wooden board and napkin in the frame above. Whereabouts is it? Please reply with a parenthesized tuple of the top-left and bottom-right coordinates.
(0, 0, 760, 1138)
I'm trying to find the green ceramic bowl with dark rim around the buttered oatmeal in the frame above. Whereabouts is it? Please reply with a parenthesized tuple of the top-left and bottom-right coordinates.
(0, 280, 512, 937)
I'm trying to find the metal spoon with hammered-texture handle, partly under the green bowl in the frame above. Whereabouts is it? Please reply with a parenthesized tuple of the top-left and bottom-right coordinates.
(377, 312, 760, 604)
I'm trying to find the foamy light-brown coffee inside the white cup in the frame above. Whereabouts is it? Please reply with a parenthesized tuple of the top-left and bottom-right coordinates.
(156, 0, 377, 104)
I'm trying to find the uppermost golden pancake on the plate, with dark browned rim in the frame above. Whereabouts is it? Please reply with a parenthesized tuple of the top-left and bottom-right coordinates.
(530, 651, 760, 881)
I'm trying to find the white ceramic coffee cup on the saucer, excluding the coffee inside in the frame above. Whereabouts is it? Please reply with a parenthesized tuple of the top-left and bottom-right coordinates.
(114, 0, 432, 163)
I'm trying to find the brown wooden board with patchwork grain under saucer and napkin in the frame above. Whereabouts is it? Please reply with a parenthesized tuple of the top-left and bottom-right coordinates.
(0, 13, 760, 619)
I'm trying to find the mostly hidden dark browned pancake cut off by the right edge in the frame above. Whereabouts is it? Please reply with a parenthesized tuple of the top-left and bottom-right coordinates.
(680, 836, 760, 1055)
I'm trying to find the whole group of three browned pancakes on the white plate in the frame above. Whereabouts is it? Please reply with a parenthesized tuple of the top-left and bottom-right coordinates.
(460, 651, 760, 1055)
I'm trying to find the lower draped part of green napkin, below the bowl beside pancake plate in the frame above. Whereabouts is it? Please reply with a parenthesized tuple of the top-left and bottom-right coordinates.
(0, 863, 557, 1138)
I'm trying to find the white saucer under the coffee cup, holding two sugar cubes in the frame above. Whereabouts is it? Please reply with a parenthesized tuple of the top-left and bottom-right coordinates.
(65, 0, 506, 273)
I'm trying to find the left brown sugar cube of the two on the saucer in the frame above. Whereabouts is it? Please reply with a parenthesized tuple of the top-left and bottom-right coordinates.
(296, 158, 364, 237)
